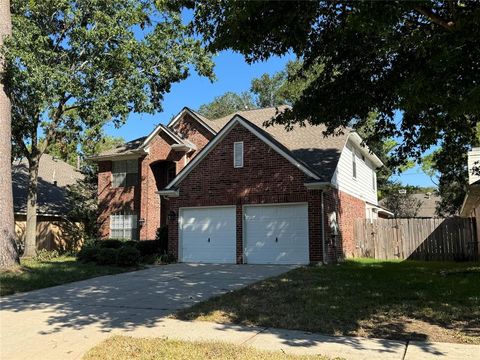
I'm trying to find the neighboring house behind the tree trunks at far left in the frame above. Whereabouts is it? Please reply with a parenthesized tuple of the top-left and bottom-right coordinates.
(12, 154, 83, 250)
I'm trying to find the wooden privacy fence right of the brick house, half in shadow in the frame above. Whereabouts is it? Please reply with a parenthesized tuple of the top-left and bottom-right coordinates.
(354, 217, 480, 260)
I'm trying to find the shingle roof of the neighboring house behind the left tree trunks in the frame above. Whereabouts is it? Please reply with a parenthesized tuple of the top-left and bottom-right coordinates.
(12, 154, 83, 215)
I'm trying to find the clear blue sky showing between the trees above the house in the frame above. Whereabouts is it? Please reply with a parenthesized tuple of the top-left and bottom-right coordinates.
(105, 51, 434, 186)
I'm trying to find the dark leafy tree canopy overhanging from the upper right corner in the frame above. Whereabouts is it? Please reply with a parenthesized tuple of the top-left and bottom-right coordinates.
(187, 0, 480, 169)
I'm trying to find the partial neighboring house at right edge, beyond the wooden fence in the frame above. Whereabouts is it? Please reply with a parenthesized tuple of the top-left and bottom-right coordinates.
(460, 147, 480, 239)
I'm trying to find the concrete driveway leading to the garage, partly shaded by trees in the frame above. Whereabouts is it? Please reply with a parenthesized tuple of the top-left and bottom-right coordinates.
(0, 264, 293, 360)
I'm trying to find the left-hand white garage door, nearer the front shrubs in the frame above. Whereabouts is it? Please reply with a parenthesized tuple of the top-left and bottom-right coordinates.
(179, 207, 236, 263)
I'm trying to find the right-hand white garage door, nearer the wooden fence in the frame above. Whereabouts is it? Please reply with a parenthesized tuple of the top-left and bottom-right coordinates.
(244, 204, 309, 264)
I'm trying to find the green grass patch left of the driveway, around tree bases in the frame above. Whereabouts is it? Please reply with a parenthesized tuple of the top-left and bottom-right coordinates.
(0, 256, 131, 296)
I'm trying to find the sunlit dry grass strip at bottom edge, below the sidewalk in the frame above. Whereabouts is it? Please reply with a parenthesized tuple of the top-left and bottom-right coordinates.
(83, 336, 340, 360)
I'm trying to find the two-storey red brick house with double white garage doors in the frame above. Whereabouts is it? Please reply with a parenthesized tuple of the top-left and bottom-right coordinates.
(89, 107, 382, 264)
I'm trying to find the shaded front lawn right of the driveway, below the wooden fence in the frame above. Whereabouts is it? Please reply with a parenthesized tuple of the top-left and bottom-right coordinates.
(176, 260, 480, 344)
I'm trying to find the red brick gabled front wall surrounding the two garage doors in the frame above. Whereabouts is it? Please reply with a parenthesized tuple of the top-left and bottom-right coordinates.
(169, 125, 321, 263)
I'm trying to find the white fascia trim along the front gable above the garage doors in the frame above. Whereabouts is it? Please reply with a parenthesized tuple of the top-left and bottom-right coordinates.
(165, 115, 319, 189)
